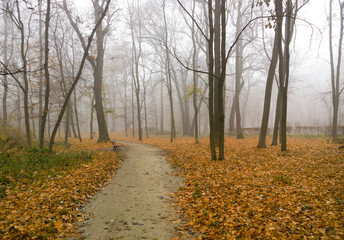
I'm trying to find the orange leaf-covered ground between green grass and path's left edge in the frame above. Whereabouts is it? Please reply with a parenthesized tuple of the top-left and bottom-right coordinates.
(0, 140, 121, 239)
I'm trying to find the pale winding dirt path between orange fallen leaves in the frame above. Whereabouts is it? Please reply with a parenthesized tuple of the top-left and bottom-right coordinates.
(80, 143, 182, 240)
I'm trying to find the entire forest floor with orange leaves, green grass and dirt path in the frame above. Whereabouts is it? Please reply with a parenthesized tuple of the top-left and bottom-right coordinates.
(0, 136, 344, 240)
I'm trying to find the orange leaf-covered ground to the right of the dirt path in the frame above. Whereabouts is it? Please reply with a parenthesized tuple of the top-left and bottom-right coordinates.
(117, 138, 344, 239)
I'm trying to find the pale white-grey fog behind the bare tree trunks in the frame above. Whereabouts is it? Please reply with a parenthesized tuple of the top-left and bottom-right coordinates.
(0, 0, 344, 142)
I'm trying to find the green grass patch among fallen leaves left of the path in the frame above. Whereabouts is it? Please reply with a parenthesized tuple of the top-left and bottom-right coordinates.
(0, 148, 93, 198)
